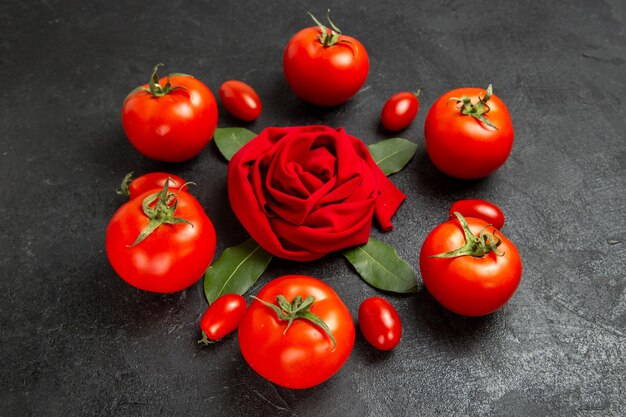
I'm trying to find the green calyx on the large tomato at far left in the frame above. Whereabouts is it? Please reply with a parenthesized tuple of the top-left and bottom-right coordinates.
(128, 178, 194, 248)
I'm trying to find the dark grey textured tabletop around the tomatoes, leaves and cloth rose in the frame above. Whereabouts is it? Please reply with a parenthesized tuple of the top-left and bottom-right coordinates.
(0, 0, 626, 417)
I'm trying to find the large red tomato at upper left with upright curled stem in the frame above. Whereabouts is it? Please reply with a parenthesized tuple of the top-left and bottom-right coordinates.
(122, 64, 217, 162)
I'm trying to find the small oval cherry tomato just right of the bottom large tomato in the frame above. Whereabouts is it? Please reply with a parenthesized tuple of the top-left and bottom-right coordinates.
(359, 297, 402, 350)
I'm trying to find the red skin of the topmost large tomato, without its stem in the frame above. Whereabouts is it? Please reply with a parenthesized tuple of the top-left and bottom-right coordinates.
(283, 27, 369, 106)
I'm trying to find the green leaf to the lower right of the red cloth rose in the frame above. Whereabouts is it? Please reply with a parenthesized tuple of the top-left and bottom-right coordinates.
(343, 239, 417, 293)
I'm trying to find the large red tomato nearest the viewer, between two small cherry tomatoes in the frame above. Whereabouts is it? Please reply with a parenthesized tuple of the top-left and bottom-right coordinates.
(239, 275, 354, 388)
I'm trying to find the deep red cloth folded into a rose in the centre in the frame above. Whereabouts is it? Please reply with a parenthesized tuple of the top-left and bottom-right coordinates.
(228, 126, 406, 261)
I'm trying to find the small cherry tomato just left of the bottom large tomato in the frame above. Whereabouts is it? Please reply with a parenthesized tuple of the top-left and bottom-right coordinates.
(200, 294, 247, 343)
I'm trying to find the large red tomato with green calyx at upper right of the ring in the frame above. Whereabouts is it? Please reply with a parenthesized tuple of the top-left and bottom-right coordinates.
(424, 85, 513, 179)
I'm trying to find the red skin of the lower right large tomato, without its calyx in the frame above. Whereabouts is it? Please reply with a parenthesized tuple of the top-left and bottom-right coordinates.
(420, 217, 522, 316)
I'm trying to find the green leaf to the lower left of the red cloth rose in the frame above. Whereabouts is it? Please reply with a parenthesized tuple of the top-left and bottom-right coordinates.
(204, 239, 272, 304)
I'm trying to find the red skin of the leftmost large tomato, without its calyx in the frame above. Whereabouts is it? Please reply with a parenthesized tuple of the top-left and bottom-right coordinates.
(106, 189, 215, 293)
